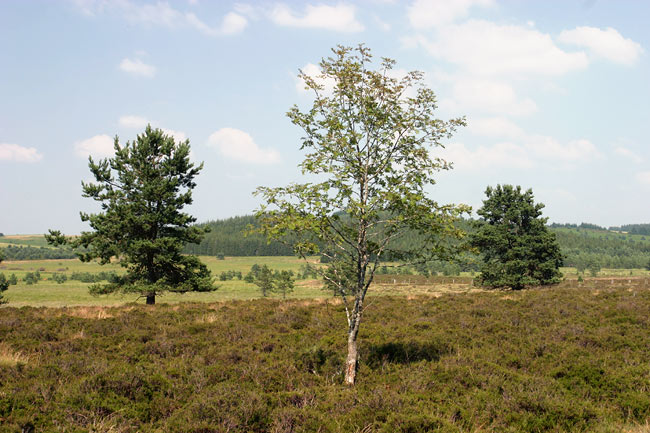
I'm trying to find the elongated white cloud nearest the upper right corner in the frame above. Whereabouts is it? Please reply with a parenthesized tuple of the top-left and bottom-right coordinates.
(558, 26, 643, 65)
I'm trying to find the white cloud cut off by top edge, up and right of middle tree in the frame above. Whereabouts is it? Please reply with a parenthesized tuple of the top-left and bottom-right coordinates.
(408, 0, 494, 29)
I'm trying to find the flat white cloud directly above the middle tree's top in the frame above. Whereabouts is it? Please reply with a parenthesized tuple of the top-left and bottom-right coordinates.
(270, 3, 364, 32)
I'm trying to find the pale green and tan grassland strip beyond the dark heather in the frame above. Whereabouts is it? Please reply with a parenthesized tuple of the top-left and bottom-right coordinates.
(0, 256, 650, 307)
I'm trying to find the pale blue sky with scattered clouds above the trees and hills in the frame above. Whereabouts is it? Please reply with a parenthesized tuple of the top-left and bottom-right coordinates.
(0, 0, 650, 234)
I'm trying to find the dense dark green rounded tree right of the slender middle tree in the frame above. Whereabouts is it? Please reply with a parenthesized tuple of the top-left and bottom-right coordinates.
(470, 185, 562, 290)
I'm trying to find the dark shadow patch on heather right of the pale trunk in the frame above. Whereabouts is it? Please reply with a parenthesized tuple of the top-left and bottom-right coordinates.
(365, 341, 451, 368)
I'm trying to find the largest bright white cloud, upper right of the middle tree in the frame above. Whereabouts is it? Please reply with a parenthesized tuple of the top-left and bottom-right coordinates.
(416, 20, 588, 78)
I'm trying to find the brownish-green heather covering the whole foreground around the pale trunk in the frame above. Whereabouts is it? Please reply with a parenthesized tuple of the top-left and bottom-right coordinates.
(0, 287, 650, 433)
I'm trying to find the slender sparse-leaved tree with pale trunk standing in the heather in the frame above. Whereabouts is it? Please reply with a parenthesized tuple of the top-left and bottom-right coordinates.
(256, 45, 467, 384)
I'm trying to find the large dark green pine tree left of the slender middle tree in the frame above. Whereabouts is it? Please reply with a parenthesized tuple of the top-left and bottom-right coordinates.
(46, 126, 216, 304)
